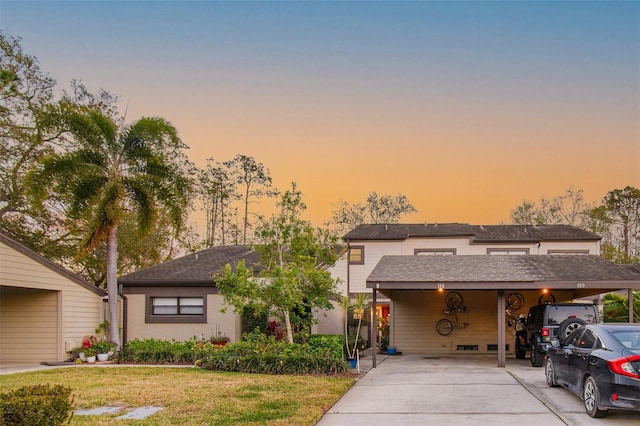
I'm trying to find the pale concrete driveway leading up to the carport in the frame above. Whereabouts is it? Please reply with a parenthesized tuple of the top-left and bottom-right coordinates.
(318, 355, 640, 426)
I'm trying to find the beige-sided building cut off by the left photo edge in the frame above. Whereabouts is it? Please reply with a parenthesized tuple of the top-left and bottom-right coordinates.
(0, 233, 106, 365)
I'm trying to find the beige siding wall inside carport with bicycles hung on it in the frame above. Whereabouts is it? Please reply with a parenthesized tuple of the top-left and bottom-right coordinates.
(391, 291, 571, 355)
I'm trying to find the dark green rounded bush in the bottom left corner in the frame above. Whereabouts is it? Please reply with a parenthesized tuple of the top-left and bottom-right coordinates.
(0, 384, 73, 426)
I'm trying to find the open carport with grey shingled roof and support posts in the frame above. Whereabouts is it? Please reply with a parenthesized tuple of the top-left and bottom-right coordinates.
(367, 255, 640, 367)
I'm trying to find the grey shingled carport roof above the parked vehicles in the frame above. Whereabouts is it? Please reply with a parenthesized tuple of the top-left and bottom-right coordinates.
(367, 255, 640, 289)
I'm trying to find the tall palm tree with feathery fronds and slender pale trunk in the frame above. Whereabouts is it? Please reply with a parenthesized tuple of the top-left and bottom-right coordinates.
(30, 109, 191, 350)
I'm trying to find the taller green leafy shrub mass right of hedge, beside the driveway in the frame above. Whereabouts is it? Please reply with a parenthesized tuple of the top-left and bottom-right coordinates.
(202, 332, 349, 374)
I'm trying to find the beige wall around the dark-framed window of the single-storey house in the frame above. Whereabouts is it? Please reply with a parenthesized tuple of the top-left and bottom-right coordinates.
(127, 294, 241, 342)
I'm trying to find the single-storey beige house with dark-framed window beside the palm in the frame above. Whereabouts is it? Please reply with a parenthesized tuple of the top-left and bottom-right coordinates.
(118, 245, 343, 342)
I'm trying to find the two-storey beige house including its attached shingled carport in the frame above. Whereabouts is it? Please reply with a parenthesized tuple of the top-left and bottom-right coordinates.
(343, 223, 640, 366)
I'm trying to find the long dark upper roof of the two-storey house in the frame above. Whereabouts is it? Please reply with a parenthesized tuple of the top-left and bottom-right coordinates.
(343, 223, 601, 243)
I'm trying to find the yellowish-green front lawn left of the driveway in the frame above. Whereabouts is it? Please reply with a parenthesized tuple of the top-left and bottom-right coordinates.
(0, 366, 355, 425)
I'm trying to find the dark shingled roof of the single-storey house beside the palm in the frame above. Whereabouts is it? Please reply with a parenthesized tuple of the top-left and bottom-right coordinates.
(118, 245, 259, 285)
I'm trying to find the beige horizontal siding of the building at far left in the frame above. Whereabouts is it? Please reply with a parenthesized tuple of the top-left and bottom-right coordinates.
(0, 243, 104, 361)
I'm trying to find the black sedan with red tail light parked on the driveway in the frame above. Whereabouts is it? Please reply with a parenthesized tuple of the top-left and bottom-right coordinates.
(545, 324, 640, 417)
